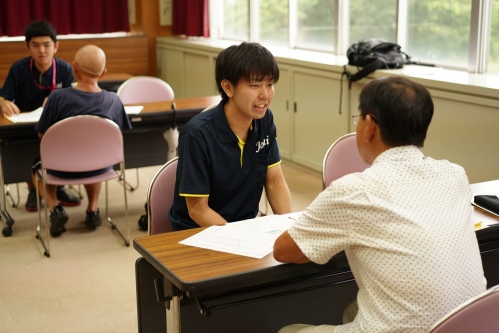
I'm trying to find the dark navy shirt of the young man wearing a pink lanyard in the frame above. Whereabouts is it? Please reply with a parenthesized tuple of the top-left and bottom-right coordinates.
(0, 57, 74, 112)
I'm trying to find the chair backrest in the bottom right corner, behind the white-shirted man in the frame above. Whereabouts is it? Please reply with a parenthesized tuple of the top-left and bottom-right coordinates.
(428, 285, 499, 333)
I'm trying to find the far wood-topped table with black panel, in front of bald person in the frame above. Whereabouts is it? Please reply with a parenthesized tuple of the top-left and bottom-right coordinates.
(0, 95, 221, 236)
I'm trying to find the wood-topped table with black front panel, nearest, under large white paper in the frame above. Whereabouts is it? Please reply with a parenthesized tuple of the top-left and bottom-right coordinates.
(133, 181, 499, 333)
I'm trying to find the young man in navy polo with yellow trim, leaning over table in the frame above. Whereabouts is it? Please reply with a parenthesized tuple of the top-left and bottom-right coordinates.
(170, 43, 291, 230)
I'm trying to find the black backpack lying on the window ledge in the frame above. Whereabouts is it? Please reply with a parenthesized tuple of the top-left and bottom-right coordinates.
(343, 38, 411, 82)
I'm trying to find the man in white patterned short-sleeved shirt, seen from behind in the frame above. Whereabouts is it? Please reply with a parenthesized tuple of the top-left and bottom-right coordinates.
(274, 76, 486, 333)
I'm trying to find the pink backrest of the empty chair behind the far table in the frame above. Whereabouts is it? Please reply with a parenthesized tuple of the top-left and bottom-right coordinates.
(116, 76, 175, 104)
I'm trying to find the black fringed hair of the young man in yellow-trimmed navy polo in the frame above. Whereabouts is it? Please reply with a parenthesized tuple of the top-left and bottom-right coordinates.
(215, 42, 279, 101)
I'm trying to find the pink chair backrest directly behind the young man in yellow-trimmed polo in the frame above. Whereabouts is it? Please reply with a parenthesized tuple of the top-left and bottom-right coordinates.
(147, 157, 178, 235)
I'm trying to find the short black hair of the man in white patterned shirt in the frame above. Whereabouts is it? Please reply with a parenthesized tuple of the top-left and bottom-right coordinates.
(359, 76, 433, 147)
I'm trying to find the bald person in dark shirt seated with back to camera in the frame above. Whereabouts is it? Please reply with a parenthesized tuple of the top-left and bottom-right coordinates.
(33, 45, 132, 237)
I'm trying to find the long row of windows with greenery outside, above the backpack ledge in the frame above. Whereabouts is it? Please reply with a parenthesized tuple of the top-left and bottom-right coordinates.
(218, 0, 499, 73)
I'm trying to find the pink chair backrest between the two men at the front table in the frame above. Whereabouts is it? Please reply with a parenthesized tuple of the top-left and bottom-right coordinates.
(322, 132, 370, 189)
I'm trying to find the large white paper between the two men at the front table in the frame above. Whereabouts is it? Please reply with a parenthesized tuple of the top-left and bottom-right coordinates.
(179, 212, 301, 259)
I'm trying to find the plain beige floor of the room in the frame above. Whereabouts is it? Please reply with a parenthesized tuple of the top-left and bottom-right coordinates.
(0, 161, 322, 333)
